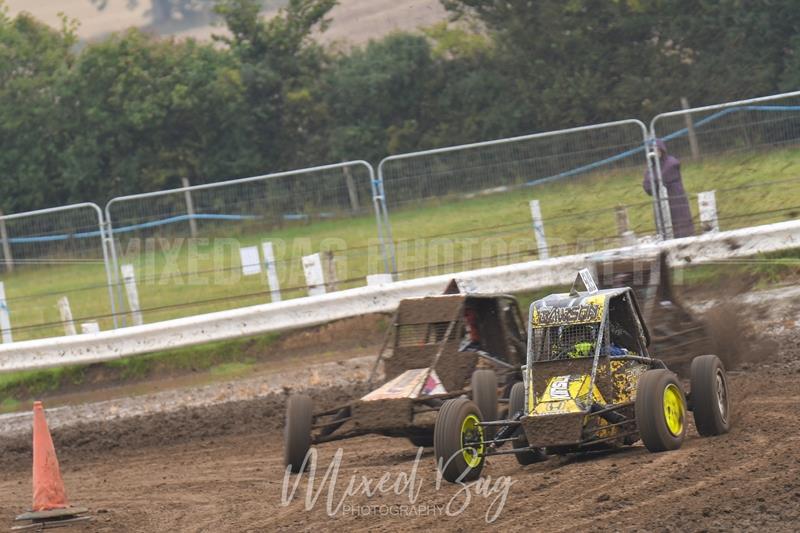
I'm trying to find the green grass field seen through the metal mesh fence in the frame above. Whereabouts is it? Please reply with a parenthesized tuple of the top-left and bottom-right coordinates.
(0, 144, 800, 340)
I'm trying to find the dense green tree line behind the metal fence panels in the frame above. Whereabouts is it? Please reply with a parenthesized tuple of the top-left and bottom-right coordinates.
(0, 0, 800, 213)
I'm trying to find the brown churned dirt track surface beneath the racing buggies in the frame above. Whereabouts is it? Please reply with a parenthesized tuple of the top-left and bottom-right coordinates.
(0, 288, 800, 531)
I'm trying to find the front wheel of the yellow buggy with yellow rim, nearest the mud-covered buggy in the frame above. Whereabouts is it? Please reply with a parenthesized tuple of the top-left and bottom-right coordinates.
(433, 398, 486, 483)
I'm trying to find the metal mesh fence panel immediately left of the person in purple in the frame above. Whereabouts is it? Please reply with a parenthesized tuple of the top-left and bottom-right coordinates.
(378, 120, 658, 278)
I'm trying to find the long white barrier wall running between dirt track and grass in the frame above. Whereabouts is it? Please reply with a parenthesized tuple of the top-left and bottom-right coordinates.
(0, 217, 800, 372)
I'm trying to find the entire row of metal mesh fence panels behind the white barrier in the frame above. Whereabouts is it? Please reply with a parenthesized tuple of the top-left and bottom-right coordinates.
(0, 91, 800, 342)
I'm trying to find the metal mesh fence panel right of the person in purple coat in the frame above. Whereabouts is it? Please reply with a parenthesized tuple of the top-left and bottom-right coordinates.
(650, 91, 800, 236)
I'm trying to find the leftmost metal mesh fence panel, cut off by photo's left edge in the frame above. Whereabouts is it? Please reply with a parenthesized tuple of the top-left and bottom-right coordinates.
(0, 203, 116, 342)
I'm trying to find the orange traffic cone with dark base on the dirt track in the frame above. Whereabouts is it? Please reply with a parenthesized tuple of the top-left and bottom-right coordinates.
(12, 402, 90, 530)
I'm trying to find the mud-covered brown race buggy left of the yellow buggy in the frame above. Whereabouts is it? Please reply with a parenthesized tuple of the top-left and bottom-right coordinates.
(284, 283, 526, 472)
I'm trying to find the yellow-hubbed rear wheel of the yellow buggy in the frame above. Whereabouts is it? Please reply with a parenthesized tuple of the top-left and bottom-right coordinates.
(635, 369, 686, 452)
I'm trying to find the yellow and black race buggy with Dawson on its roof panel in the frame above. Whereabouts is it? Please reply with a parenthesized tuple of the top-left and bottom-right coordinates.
(434, 270, 730, 482)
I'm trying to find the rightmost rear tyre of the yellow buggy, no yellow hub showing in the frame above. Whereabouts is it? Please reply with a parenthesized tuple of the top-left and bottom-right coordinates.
(690, 355, 730, 437)
